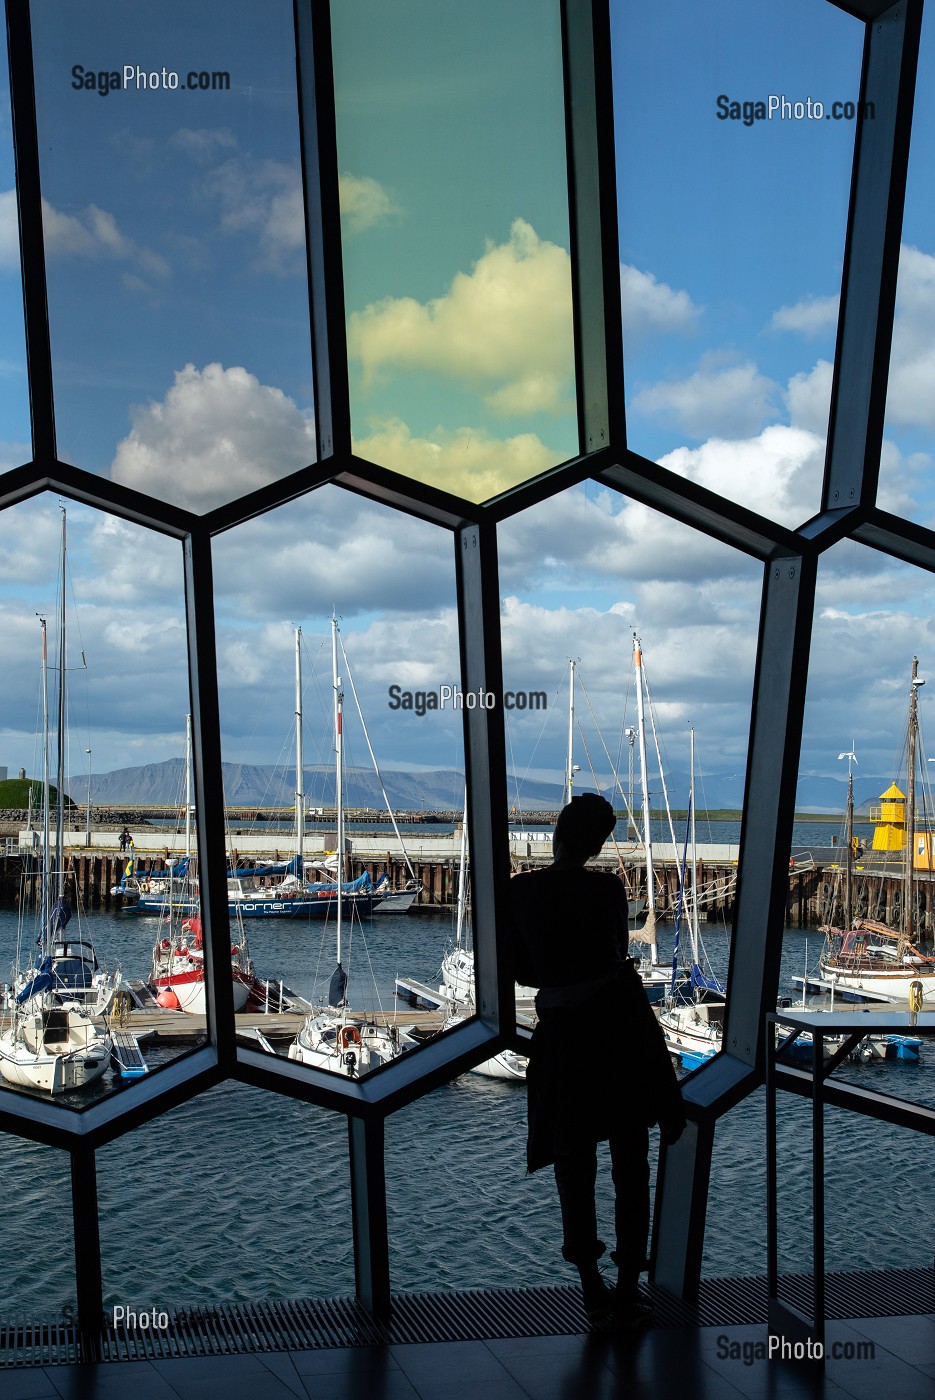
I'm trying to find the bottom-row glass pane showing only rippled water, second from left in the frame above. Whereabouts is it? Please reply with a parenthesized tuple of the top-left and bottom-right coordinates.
(98, 1084, 354, 1299)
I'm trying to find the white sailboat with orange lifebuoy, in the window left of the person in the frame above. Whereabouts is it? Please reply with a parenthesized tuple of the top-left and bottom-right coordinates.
(288, 616, 405, 1078)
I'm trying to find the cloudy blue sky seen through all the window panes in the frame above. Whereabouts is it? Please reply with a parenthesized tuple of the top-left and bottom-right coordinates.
(0, 0, 935, 804)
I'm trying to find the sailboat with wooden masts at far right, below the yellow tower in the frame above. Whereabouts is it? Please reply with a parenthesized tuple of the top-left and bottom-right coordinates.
(819, 657, 935, 1005)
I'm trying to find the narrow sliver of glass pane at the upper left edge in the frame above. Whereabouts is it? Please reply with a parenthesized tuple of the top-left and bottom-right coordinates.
(0, 16, 32, 472)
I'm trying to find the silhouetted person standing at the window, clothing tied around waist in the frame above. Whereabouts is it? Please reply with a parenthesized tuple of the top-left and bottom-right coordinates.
(509, 792, 684, 1330)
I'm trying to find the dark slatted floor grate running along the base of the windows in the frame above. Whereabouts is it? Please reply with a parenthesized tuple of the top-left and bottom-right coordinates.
(0, 1268, 935, 1368)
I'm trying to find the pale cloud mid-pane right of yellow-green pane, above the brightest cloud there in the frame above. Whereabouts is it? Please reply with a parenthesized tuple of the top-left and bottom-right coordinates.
(633, 351, 778, 437)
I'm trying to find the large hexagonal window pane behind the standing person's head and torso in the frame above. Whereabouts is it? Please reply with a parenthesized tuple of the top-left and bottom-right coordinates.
(500, 483, 761, 1054)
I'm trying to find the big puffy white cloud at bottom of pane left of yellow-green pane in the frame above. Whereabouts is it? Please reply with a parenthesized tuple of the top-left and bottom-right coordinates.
(111, 364, 315, 510)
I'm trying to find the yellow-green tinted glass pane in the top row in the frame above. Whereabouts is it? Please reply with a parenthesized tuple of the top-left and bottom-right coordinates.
(333, 0, 578, 500)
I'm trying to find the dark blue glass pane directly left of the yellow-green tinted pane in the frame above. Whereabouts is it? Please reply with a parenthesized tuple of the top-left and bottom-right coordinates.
(34, 0, 315, 510)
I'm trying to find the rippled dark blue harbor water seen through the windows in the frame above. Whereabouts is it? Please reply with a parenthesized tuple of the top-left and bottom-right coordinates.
(0, 827, 935, 1317)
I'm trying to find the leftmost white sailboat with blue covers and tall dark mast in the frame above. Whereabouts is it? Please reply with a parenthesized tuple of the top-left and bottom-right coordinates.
(0, 507, 116, 1093)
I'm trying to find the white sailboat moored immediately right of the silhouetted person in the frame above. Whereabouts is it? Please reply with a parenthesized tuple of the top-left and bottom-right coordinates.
(659, 729, 726, 1068)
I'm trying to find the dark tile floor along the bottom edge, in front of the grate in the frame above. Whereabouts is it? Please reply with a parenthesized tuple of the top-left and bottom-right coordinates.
(0, 1315, 935, 1400)
